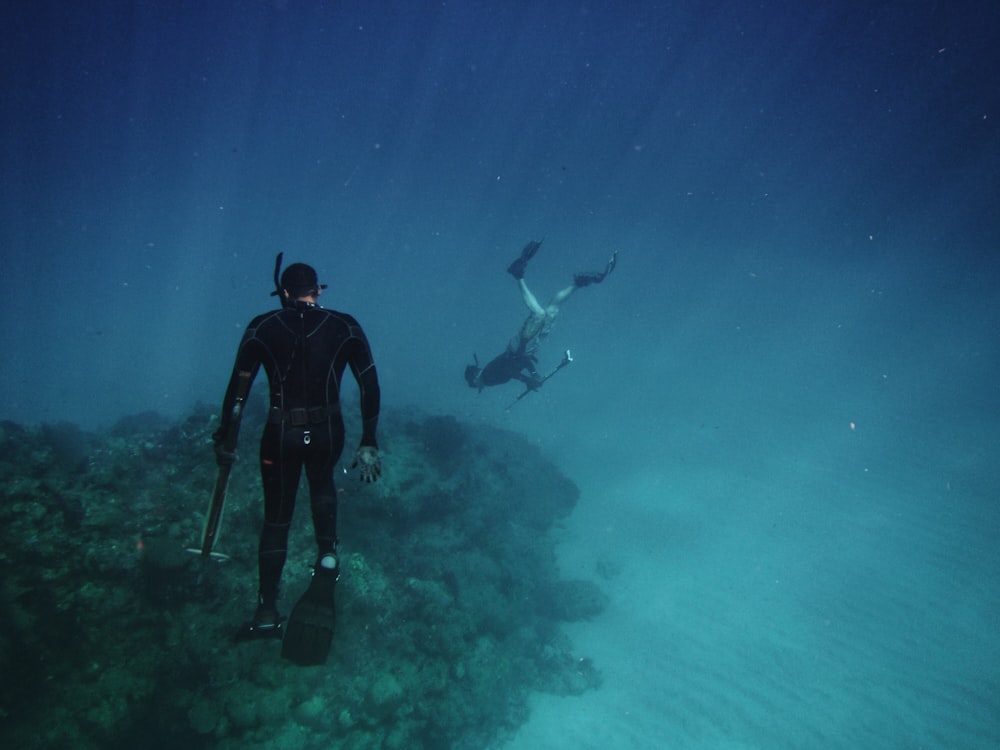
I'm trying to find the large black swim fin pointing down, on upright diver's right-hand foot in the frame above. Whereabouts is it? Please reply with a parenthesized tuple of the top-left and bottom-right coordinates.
(281, 565, 340, 667)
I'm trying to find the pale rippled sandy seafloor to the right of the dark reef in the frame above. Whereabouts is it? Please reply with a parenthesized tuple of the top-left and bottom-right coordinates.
(508, 384, 1000, 750)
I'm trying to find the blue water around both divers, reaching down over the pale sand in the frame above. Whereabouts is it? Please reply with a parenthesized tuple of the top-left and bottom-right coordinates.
(0, 0, 1000, 750)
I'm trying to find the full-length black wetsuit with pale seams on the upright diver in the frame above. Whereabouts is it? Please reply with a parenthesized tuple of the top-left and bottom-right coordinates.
(216, 301, 380, 605)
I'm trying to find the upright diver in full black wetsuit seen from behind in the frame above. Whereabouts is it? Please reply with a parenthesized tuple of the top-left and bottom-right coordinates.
(213, 254, 382, 663)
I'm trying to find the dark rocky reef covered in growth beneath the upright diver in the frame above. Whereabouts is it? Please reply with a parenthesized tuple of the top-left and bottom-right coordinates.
(0, 407, 606, 750)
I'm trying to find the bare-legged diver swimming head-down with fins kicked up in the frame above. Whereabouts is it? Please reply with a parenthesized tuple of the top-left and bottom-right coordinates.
(465, 241, 618, 391)
